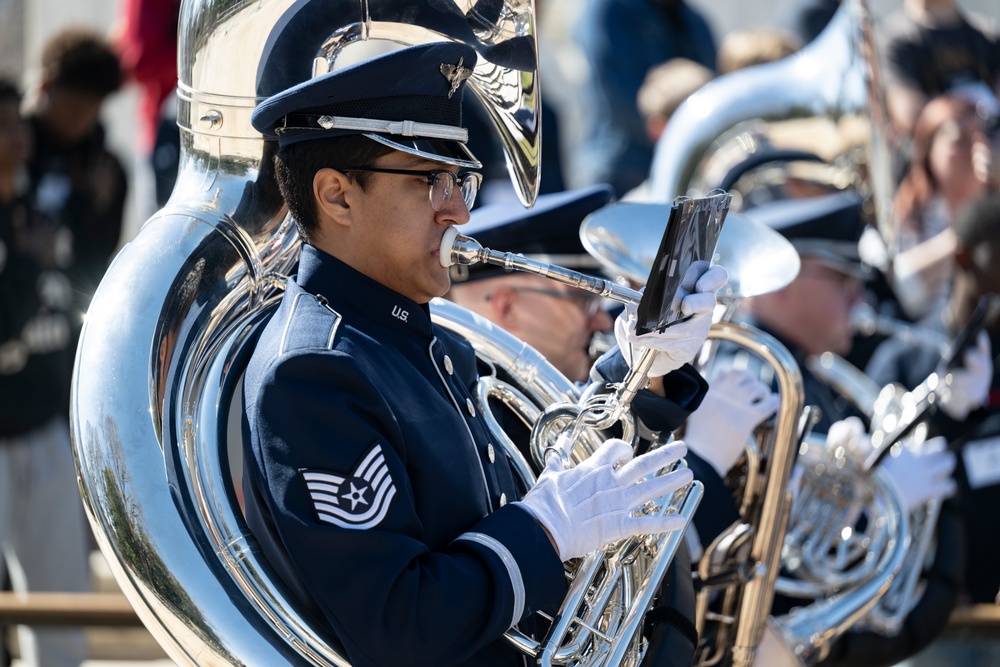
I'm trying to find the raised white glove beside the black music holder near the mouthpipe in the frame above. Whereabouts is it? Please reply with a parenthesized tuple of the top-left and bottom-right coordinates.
(615, 261, 729, 377)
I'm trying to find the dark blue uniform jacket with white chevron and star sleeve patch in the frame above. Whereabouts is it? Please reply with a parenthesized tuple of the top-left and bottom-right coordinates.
(244, 246, 704, 666)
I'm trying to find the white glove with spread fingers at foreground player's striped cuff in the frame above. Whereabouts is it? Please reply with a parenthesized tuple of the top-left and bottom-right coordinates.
(518, 438, 692, 561)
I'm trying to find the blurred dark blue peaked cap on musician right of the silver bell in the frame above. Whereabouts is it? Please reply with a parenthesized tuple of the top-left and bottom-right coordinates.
(740, 190, 865, 276)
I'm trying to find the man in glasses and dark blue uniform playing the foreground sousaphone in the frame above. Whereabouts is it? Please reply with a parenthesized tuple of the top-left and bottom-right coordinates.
(244, 43, 726, 665)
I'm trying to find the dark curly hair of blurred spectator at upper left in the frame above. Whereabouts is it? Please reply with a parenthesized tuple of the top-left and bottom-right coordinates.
(42, 28, 123, 98)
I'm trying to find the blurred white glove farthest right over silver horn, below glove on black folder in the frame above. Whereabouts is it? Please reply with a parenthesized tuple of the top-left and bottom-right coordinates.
(882, 436, 955, 512)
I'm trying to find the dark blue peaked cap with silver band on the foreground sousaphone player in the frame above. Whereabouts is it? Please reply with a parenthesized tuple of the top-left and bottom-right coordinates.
(250, 42, 482, 169)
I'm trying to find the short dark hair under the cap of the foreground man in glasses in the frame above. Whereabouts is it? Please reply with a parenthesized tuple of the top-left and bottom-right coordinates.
(274, 135, 393, 243)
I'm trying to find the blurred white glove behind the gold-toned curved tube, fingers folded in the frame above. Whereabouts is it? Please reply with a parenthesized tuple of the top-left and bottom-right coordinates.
(684, 370, 781, 477)
